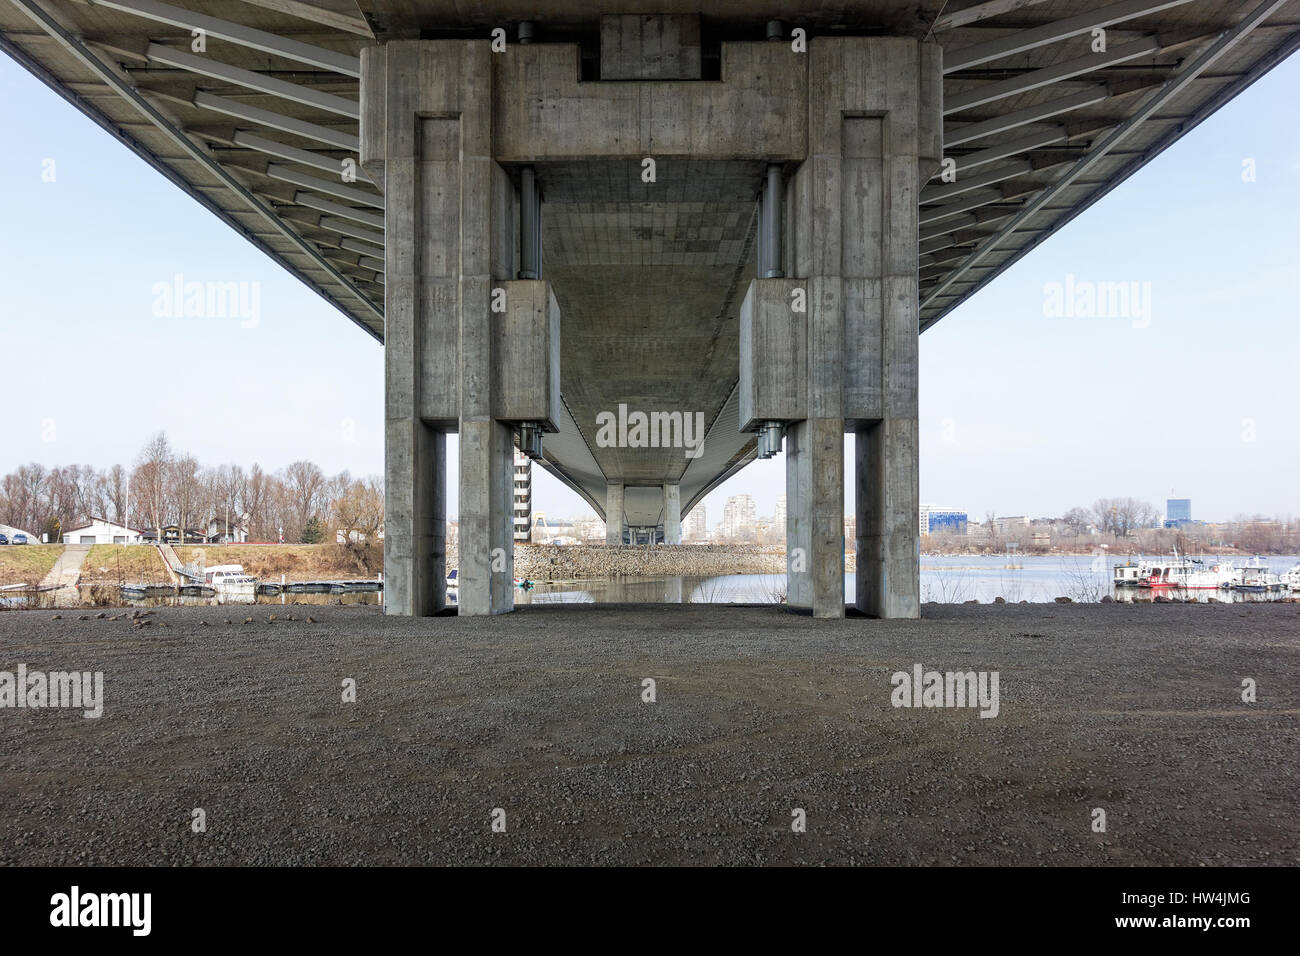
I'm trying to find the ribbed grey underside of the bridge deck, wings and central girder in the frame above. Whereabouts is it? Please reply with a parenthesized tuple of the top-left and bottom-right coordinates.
(0, 0, 1300, 514)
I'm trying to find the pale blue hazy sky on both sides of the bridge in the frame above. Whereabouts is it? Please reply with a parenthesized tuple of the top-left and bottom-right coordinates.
(0, 48, 1300, 527)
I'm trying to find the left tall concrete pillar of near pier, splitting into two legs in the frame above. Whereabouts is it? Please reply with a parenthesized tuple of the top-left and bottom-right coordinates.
(361, 40, 515, 615)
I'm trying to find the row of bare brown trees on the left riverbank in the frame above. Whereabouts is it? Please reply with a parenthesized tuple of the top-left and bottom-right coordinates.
(0, 432, 384, 544)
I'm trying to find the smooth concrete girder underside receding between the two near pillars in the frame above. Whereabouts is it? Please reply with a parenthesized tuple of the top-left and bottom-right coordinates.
(538, 160, 763, 524)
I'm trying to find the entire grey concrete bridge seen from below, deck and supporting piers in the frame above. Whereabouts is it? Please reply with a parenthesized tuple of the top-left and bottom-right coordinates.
(0, 0, 1300, 617)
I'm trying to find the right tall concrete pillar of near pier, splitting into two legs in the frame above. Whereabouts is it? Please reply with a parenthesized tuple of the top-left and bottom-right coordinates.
(776, 36, 941, 618)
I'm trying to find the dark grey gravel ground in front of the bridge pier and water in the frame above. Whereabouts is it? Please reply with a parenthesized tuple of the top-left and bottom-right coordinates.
(0, 605, 1300, 865)
